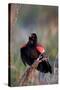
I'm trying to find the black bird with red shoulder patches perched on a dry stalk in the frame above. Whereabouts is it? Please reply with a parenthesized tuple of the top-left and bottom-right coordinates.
(20, 33, 52, 73)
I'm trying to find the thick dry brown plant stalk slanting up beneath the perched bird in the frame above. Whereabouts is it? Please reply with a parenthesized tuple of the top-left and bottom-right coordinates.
(19, 60, 40, 86)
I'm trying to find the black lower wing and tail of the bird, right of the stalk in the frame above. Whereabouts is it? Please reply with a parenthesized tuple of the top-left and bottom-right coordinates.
(37, 53, 52, 73)
